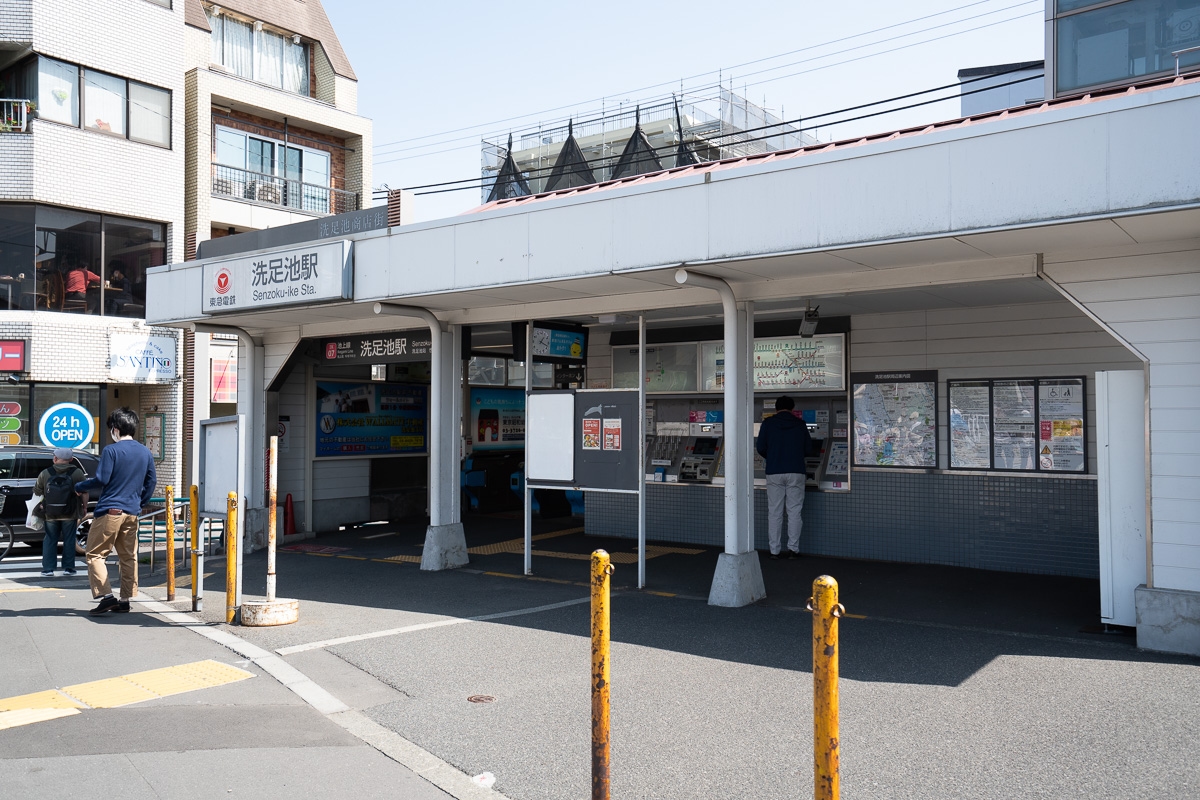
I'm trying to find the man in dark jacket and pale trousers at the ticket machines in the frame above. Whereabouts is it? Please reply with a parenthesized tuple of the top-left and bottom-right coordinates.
(755, 395, 812, 559)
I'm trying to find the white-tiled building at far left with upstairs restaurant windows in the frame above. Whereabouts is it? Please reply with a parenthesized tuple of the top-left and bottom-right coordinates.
(0, 0, 185, 489)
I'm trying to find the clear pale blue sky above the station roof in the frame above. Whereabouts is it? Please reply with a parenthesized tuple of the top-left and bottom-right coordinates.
(324, 0, 1045, 221)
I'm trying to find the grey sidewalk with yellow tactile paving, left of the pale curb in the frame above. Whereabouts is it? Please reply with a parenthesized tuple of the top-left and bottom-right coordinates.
(0, 565, 450, 800)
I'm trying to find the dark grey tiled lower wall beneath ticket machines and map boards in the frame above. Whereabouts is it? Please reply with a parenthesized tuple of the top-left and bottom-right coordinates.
(584, 471, 1099, 578)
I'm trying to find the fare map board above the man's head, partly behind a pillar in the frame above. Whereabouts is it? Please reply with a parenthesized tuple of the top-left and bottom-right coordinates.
(701, 333, 846, 392)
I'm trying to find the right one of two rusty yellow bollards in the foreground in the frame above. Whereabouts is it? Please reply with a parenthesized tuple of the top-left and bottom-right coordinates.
(809, 575, 846, 800)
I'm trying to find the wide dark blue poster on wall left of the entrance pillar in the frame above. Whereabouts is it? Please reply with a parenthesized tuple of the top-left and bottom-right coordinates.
(316, 380, 428, 458)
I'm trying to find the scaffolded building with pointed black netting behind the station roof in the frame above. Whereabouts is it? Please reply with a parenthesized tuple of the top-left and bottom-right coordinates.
(481, 89, 816, 203)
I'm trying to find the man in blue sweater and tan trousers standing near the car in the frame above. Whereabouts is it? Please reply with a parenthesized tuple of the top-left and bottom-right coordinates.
(76, 408, 158, 614)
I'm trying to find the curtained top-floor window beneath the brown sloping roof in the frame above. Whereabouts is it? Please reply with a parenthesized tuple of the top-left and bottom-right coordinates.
(205, 10, 308, 96)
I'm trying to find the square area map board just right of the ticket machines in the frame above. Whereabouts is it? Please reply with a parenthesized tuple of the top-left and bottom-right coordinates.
(851, 369, 937, 469)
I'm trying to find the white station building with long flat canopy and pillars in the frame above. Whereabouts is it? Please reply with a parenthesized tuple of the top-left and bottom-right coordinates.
(149, 61, 1200, 654)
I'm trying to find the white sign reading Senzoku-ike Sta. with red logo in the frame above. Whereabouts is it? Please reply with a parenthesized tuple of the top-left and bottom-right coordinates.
(200, 240, 354, 314)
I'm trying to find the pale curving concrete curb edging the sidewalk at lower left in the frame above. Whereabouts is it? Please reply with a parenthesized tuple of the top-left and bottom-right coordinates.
(133, 594, 510, 800)
